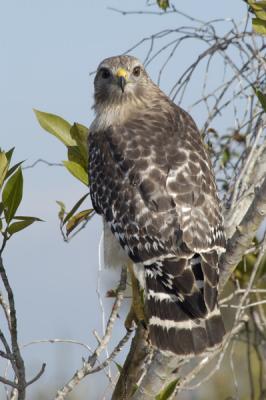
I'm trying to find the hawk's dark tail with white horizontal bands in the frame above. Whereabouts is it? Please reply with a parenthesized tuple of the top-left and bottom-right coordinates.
(144, 252, 225, 356)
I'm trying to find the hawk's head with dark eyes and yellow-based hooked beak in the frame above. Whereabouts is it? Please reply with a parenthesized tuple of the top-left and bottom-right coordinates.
(94, 55, 151, 106)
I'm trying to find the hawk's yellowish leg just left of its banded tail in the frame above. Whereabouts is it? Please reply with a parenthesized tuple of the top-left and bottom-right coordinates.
(125, 263, 146, 330)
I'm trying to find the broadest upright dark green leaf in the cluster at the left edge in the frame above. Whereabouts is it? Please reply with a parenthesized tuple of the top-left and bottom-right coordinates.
(2, 167, 23, 224)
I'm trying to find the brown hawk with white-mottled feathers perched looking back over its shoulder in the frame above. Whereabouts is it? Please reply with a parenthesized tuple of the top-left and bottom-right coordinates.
(89, 55, 225, 356)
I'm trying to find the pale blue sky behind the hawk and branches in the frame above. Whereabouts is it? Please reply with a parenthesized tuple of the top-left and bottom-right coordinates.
(0, 0, 246, 400)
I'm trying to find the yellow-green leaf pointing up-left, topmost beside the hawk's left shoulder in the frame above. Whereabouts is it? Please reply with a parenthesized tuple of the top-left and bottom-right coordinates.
(33, 110, 76, 146)
